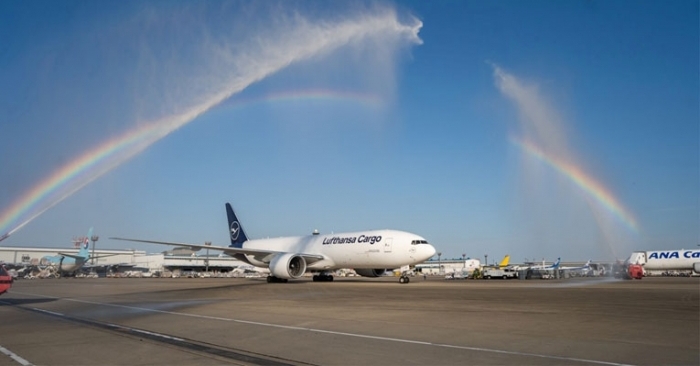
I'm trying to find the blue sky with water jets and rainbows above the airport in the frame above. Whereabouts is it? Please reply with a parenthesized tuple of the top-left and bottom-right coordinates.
(0, 1, 700, 262)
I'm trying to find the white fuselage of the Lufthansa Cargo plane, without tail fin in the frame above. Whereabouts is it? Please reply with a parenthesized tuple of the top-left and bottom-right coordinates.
(243, 230, 435, 271)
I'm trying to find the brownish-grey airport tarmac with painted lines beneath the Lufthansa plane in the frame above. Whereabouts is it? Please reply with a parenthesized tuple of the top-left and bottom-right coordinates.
(0, 277, 700, 366)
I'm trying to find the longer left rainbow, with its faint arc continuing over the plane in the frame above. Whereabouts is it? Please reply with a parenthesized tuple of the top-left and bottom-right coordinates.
(0, 90, 382, 235)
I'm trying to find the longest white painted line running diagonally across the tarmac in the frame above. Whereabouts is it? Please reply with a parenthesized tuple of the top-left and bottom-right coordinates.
(9, 291, 634, 366)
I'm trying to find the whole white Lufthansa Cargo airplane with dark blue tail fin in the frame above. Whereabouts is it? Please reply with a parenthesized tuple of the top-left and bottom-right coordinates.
(110, 203, 435, 283)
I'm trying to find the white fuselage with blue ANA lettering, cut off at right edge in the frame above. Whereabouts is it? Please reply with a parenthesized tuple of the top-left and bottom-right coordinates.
(627, 249, 700, 271)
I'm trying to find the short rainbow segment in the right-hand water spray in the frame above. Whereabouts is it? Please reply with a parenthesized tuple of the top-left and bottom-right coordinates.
(510, 138, 638, 232)
